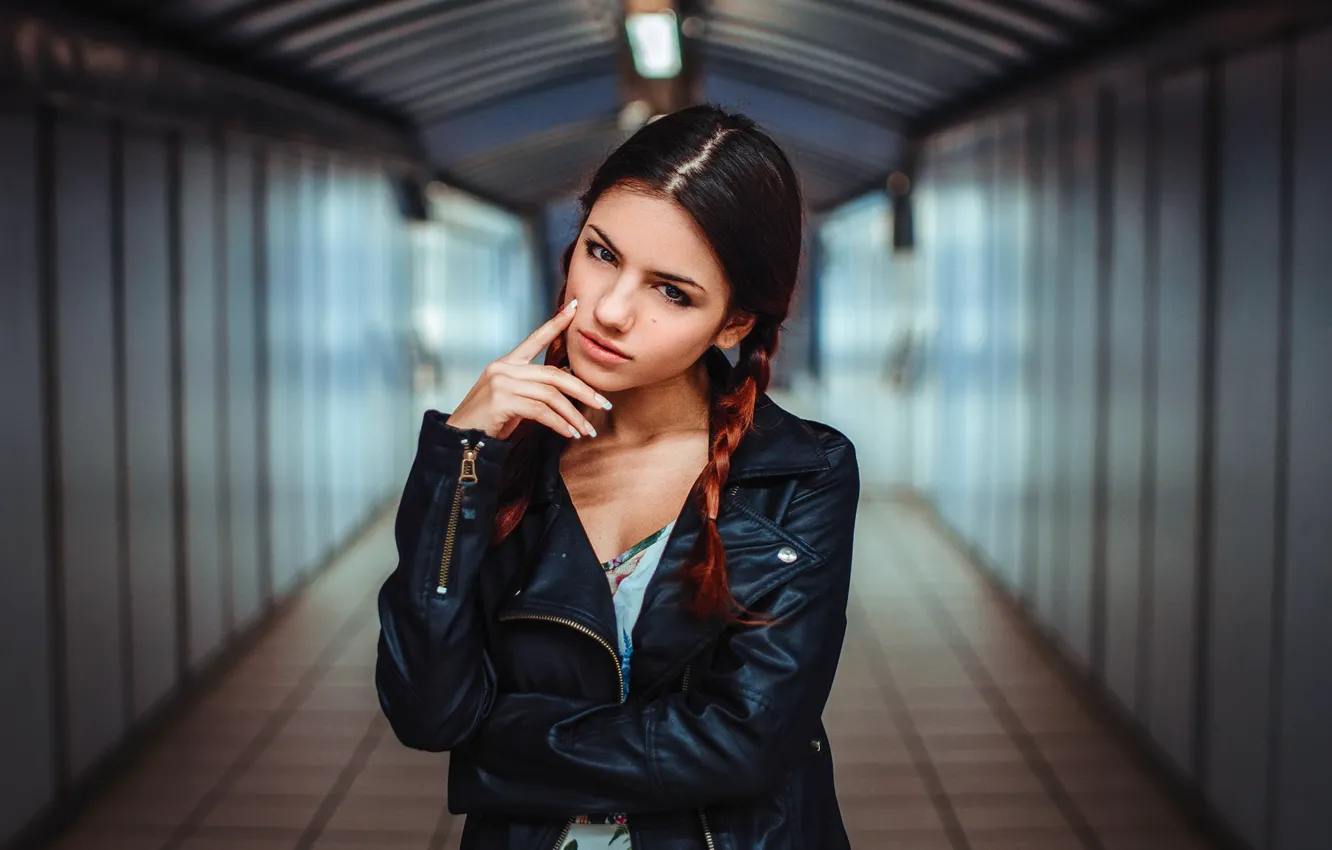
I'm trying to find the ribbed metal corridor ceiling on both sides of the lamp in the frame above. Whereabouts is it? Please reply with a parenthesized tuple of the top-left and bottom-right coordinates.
(85, 0, 1158, 208)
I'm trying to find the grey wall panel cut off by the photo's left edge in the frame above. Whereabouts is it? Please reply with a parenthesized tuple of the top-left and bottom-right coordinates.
(0, 112, 56, 835)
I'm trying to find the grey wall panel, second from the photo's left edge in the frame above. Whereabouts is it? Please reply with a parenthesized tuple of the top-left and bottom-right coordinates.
(55, 117, 127, 775)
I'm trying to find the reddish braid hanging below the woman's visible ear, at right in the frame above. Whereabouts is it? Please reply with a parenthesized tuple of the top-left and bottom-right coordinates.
(686, 325, 778, 624)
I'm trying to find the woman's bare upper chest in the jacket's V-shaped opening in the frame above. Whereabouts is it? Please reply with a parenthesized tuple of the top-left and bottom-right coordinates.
(559, 434, 707, 564)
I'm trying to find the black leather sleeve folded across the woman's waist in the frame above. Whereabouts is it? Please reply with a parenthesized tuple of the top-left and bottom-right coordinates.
(449, 438, 859, 817)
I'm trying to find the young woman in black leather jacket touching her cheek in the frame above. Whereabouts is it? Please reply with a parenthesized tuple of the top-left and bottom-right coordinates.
(376, 107, 859, 850)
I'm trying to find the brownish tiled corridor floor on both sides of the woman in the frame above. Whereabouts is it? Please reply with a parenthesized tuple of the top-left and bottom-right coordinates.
(46, 501, 1207, 850)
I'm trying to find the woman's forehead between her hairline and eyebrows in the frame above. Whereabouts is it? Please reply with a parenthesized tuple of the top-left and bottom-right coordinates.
(587, 188, 725, 285)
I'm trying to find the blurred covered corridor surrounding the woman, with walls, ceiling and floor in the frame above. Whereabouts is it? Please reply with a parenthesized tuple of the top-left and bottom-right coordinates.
(0, 0, 1332, 850)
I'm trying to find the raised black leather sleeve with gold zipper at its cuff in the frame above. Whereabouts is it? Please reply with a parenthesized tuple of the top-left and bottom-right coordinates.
(374, 410, 513, 751)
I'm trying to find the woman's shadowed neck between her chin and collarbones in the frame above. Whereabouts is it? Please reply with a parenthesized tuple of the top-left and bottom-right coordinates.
(583, 361, 709, 444)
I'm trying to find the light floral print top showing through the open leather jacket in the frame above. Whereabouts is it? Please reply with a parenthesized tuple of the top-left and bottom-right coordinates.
(559, 522, 675, 850)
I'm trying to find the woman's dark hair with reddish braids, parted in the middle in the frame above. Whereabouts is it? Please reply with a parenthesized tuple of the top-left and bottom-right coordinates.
(493, 105, 805, 621)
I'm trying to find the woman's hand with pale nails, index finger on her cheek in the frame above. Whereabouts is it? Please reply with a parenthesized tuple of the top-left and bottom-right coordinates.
(448, 298, 610, 440)
